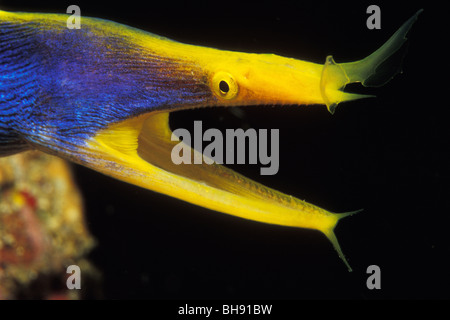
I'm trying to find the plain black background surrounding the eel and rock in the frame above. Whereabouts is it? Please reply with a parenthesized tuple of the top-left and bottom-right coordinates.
(0, 0, 450, 299)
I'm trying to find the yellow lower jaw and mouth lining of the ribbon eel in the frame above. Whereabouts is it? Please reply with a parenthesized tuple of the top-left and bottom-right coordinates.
(89, 112, 355, 270)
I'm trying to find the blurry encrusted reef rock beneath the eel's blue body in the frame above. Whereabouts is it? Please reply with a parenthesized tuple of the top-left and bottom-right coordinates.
(0, 151, 99, 299)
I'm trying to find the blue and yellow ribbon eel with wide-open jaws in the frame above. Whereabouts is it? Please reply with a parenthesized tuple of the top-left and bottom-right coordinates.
(0, 11, 421, 271)
